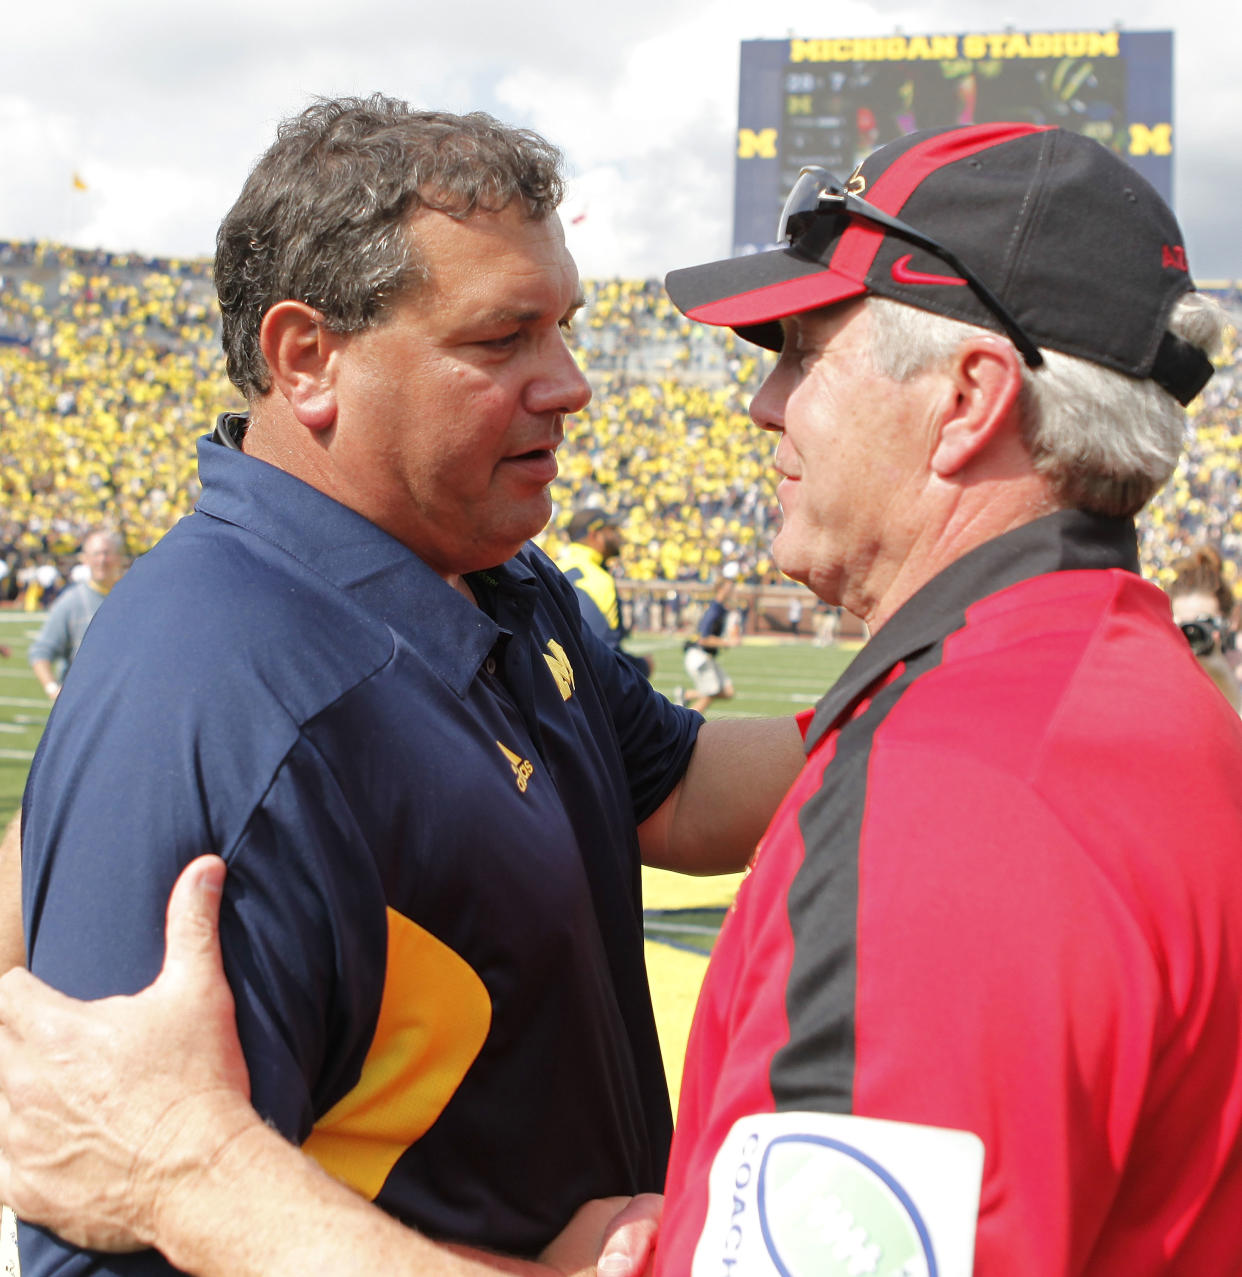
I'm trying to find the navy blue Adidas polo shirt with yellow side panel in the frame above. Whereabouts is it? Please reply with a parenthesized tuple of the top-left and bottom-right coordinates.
(22, 426, 701, 1277)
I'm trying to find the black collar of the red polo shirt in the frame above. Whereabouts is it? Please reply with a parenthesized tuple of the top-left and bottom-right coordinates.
(805, 510, 1139, 753)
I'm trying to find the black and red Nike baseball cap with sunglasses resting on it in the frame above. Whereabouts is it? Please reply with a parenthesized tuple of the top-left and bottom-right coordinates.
(665, 124, 1213, 404)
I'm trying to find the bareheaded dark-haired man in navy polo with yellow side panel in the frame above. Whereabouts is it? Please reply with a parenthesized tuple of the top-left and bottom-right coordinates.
(4, 97, 798, 1277)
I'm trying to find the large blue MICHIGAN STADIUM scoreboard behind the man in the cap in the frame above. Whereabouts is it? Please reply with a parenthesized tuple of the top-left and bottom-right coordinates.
(733, 29, 1173, 254)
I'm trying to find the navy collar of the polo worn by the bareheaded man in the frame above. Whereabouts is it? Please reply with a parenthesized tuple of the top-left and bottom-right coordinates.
(197, 412, 535, 696)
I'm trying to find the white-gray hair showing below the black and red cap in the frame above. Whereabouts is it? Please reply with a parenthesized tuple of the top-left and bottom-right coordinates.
(867, 292, 1227, 515)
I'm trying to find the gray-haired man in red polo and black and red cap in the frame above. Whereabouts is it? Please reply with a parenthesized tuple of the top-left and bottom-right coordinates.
(655, 124, 1242, 1277)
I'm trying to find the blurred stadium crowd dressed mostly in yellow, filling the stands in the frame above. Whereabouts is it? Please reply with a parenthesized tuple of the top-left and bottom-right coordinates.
(0, 241, 1242, 607)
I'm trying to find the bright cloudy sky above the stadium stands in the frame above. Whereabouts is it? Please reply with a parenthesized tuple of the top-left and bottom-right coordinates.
(0, 0, 1242, 278)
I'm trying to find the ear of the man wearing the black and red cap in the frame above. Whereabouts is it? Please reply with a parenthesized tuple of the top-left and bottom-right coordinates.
(932, 336, 1022, 479)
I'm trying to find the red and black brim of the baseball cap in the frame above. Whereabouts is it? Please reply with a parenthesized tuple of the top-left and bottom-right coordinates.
(664, 249, 867, 350)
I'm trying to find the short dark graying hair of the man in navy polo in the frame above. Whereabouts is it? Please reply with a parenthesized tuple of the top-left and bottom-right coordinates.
(216, 94, 564, 398)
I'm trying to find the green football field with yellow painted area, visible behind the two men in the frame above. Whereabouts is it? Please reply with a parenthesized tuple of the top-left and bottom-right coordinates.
(0, 609, 858, 1103)
